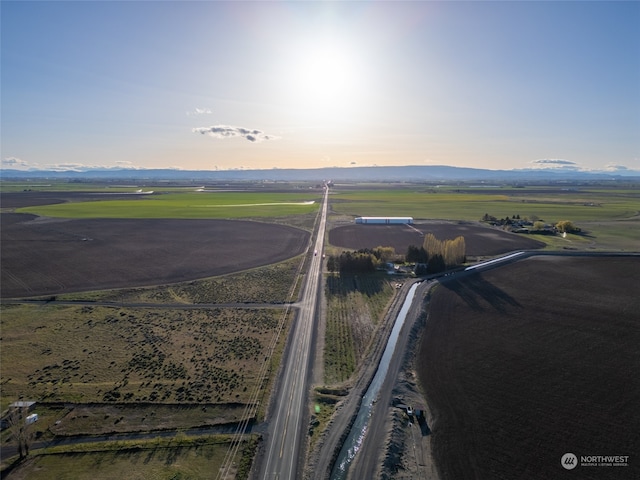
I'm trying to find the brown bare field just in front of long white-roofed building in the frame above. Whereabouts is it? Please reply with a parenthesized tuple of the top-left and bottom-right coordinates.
(329, 222, 545, 256)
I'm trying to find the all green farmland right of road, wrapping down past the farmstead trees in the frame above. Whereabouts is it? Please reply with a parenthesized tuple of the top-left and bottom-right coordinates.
(331, 185, 640, 250)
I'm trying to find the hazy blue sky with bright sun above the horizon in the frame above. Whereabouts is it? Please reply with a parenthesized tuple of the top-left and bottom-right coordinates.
(0, 0, 640, 171)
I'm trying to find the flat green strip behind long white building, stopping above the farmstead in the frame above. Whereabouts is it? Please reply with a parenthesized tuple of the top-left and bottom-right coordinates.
(331, 187, 640, 222)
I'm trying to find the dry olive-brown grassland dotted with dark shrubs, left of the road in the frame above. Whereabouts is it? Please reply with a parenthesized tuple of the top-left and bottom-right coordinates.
(0, 305, 290, 404)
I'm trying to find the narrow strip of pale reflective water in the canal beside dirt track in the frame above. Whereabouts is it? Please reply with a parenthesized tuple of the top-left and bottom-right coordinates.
(331, 283, 418, 480)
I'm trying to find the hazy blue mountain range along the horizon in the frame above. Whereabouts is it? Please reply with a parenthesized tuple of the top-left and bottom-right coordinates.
(0, 165, 640, 183)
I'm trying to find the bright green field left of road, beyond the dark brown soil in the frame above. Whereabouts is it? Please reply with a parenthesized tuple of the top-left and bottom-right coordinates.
(16, 192, 321, 218)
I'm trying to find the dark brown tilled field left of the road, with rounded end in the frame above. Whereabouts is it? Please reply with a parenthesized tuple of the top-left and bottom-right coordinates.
(0, 213, 309, 298)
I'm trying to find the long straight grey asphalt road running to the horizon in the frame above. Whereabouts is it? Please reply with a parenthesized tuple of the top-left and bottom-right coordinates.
(260, 190, 328, 480)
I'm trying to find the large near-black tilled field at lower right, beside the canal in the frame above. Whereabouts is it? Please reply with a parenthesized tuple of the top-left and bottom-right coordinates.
(418, 256, 640, 480)
